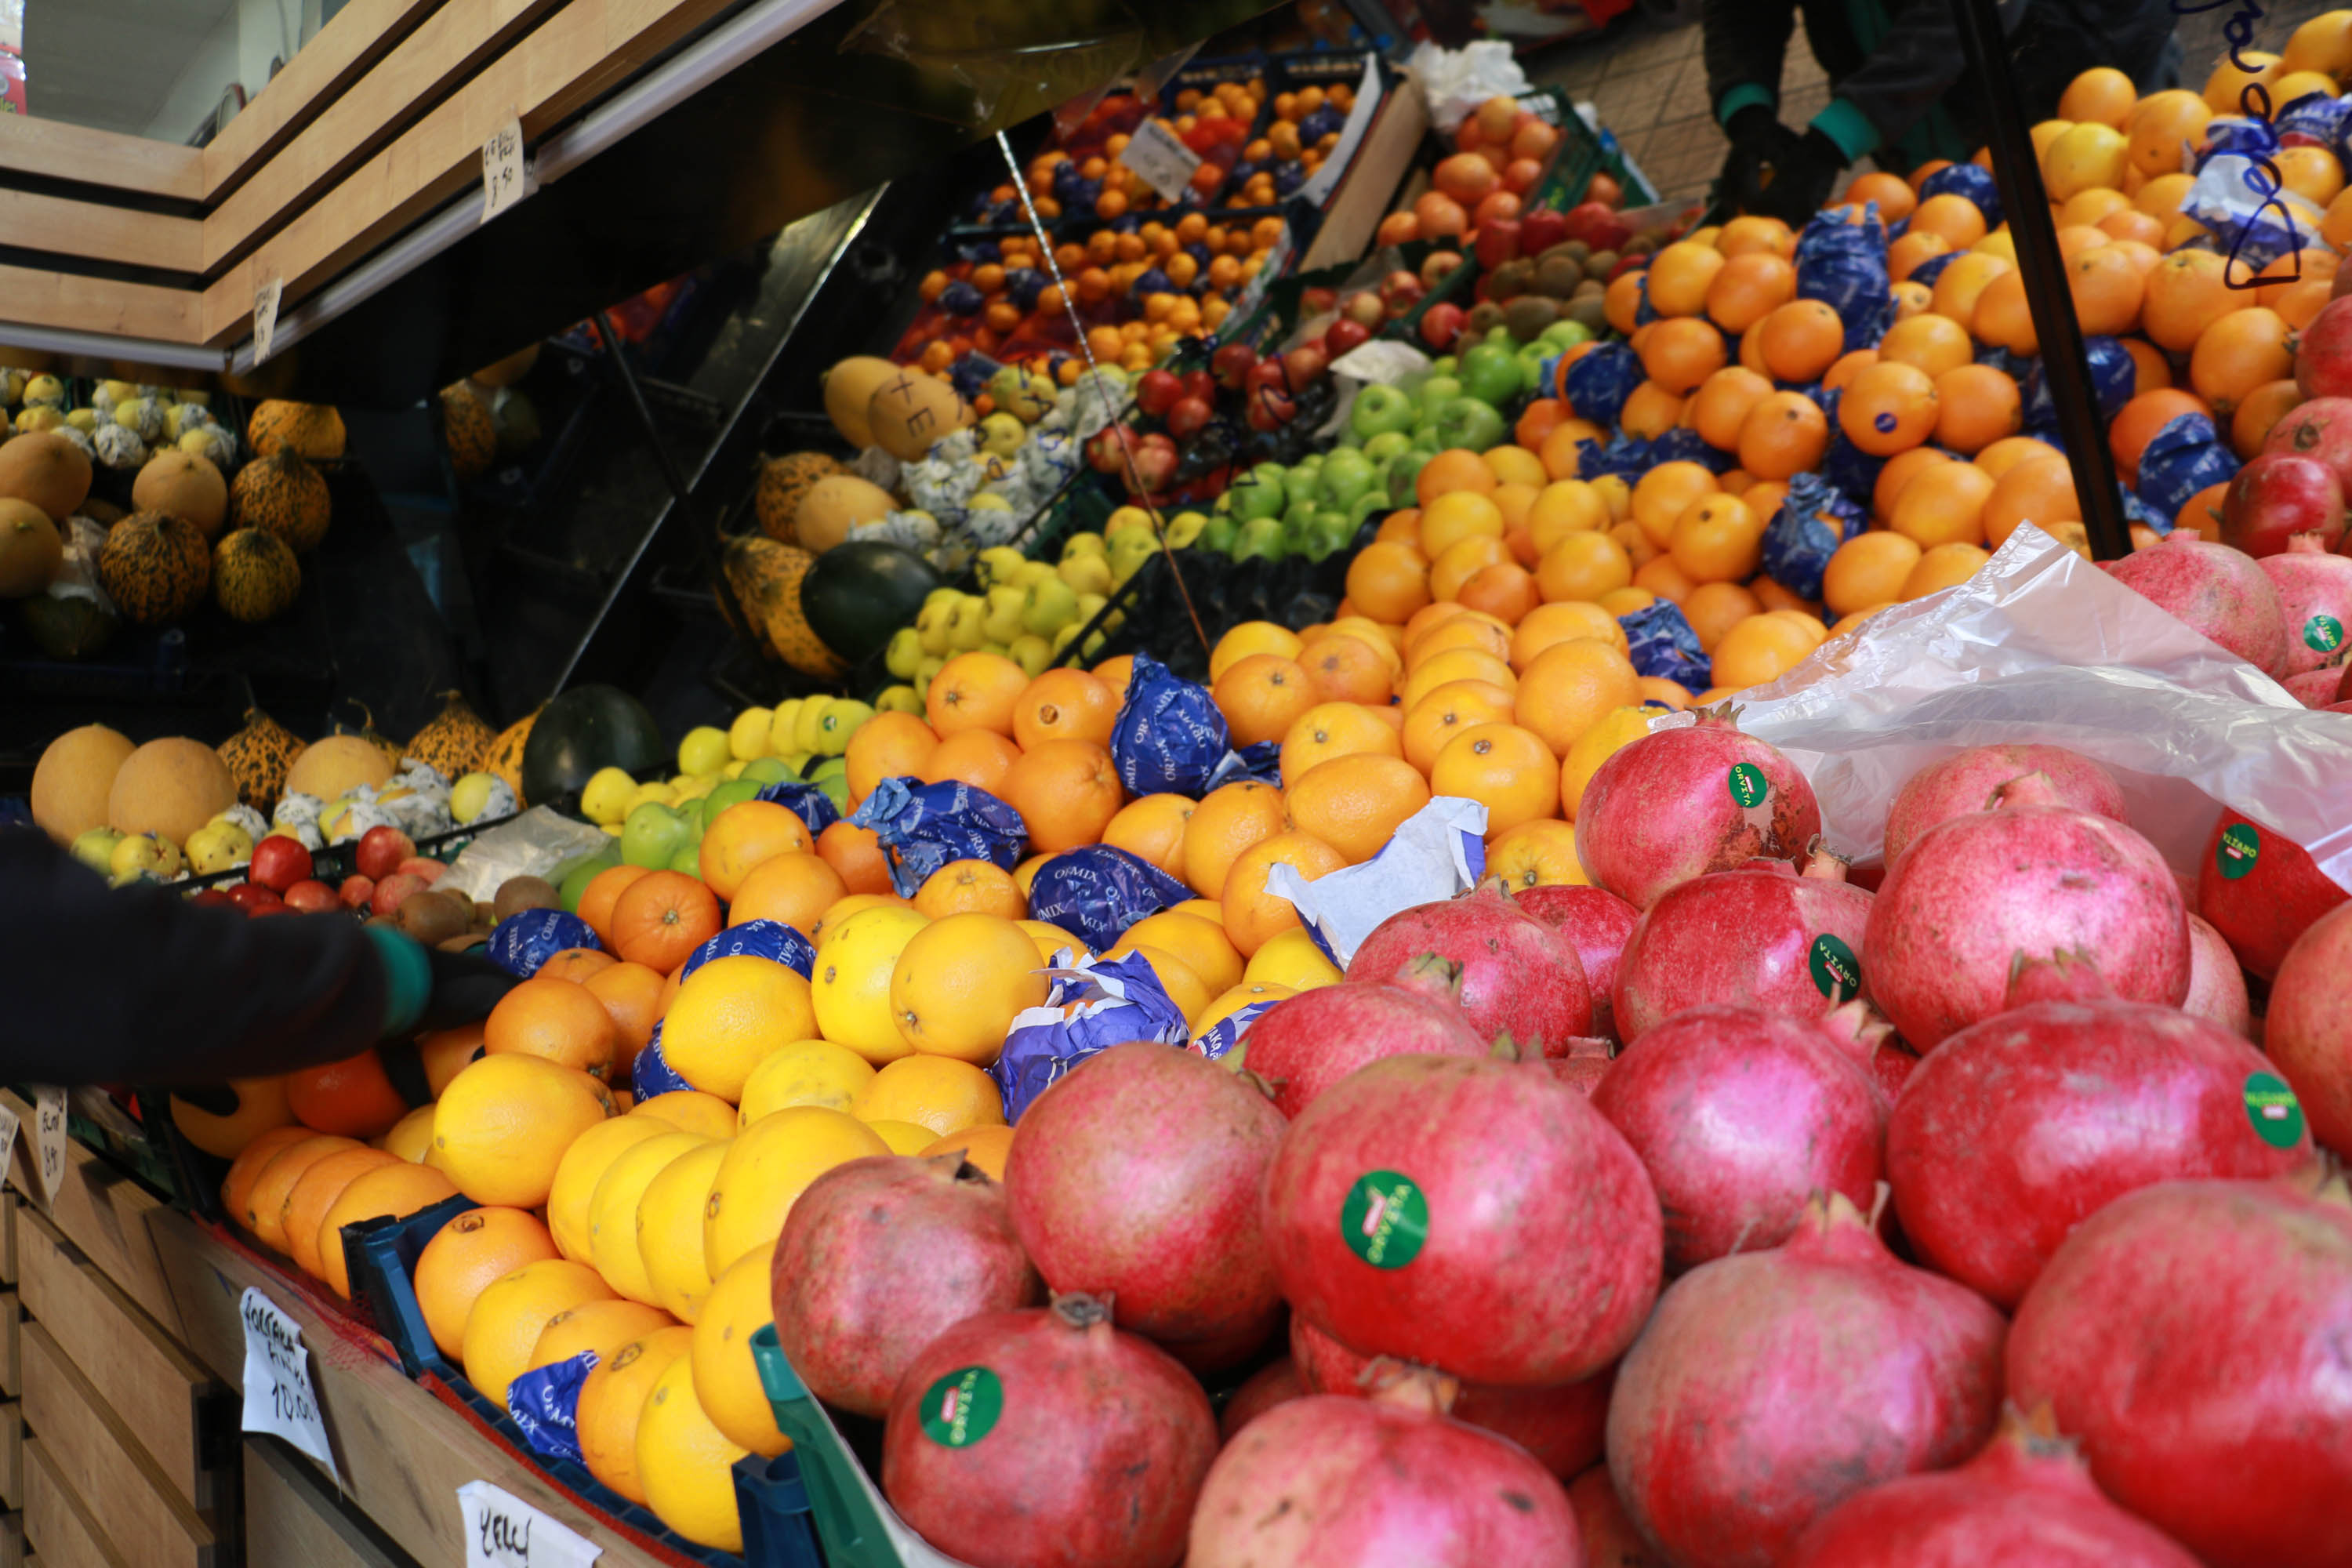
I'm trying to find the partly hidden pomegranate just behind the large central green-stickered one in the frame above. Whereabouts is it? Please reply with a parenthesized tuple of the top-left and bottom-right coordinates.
(1242, 954, 1489, 1116)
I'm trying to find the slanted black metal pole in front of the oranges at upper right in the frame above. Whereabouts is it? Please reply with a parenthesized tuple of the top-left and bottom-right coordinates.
(1952, 0, 2131, 562)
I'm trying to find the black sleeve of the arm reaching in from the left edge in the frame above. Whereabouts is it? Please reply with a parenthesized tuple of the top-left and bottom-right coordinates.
(0, 829, 383, 1086)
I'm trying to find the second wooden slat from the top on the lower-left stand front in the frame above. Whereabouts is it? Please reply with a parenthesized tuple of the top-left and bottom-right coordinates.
(19, 1210, 226, 1509)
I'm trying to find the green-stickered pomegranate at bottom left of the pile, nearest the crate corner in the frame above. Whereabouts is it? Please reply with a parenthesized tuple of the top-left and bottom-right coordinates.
(882, 1298, 1214, 1568)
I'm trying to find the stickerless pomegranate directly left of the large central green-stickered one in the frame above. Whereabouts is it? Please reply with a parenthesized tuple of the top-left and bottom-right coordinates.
(1004, 1044, 1284, 1347)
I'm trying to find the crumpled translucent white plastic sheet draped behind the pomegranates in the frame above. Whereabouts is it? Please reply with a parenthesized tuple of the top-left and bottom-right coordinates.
(1712, 524, 2352, 888)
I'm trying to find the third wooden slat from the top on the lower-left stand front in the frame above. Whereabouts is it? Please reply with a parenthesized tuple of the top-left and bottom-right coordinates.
(24, 1323, 223, 1568)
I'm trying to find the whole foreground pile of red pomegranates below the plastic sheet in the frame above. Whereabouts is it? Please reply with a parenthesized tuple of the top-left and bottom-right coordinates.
(774, 714, 2352, 1568)
